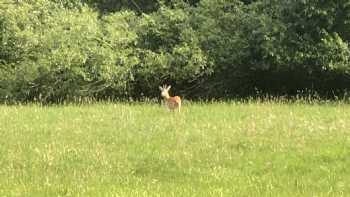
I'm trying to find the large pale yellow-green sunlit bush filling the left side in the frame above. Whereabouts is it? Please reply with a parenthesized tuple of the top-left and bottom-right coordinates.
(0, 0, 138, 102)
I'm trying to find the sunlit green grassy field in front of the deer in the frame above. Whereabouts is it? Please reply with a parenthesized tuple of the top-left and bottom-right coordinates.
(0, 102, 350, 196)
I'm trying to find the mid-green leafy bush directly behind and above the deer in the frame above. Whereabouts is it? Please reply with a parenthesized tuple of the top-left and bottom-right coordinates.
(135, 7, 212, 95)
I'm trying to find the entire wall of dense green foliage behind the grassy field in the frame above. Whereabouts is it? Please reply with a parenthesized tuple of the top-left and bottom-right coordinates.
(0, 0, 350, 102)
